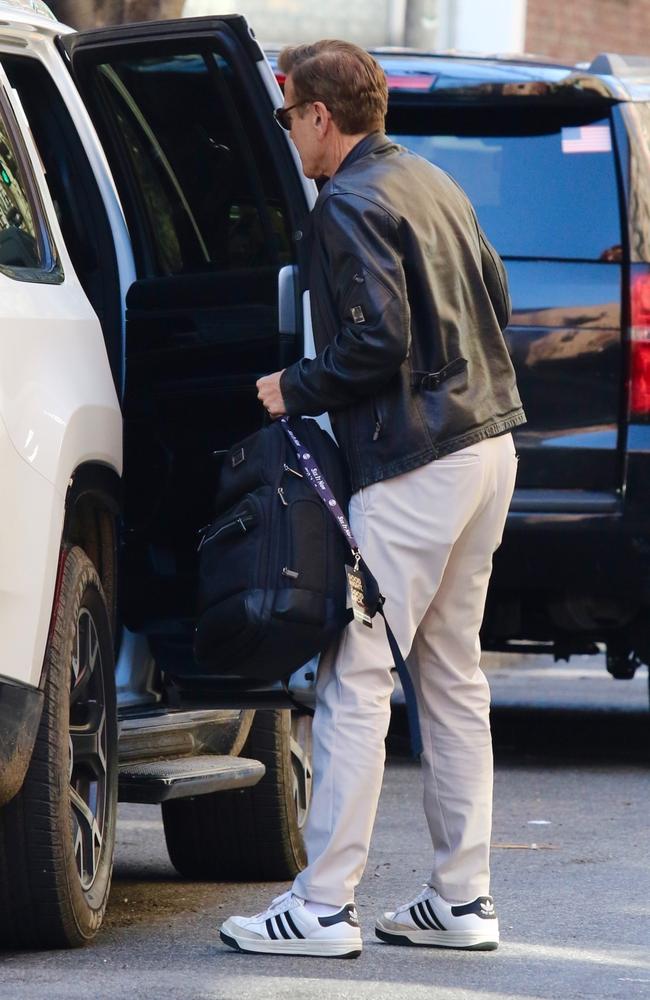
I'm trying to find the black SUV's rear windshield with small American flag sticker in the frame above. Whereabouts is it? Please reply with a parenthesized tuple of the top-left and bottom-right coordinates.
(387, 105, 621, 260)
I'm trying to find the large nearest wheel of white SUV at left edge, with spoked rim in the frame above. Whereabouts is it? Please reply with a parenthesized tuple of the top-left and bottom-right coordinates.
(0, 547, 117, 948)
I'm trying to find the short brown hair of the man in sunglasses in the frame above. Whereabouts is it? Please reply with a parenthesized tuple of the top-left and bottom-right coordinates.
(278, 38, 388, 135)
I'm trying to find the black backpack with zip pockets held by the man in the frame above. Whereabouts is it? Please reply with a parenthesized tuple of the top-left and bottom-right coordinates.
(194, 418, 350, 681)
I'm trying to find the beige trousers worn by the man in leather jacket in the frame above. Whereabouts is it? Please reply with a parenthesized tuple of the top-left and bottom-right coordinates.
(294, 434, 517, 906)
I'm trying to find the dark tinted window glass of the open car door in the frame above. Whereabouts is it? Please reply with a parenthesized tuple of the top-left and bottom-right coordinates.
(90, 52, 290, 275)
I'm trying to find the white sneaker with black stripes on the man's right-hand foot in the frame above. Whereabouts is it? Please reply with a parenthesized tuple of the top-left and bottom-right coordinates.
(375, 885, 499, 951)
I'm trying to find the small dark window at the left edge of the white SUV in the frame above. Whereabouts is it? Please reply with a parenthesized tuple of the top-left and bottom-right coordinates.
(0, 108, 41, 269)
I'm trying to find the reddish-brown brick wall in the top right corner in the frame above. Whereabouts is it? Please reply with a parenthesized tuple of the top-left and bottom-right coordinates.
(526, 0, 650, 63)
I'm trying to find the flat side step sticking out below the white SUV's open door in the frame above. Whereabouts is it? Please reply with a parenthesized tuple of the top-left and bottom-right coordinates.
(119, 754, 265, 804)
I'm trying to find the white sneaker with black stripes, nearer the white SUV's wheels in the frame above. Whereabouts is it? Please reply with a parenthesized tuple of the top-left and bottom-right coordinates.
(220, 892, 362, 958)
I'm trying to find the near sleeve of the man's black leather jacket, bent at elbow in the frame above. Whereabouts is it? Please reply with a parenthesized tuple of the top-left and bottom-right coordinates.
(280, 193, 410, 415)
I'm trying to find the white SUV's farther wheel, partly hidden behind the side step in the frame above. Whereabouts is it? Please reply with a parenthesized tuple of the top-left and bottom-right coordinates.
(162, 710, 312, 882)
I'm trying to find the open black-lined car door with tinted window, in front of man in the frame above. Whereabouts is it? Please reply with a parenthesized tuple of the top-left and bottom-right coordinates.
(60, 16, 316, 672)
